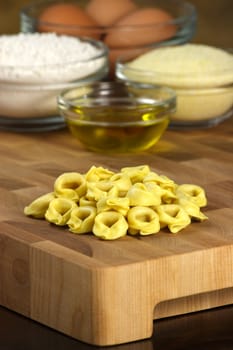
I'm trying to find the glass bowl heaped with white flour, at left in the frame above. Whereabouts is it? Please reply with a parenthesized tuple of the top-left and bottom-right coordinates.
(0, 33, 108, 131)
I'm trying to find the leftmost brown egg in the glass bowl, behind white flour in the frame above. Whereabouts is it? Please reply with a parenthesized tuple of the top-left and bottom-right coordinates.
(38, 3, 99, 39)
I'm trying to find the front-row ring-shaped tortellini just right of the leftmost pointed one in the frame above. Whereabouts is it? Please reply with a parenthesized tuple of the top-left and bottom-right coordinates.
(45, 197, 77, 226)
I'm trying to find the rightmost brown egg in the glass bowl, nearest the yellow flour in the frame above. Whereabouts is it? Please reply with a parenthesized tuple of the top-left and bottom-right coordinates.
(105, 8, 176, 48)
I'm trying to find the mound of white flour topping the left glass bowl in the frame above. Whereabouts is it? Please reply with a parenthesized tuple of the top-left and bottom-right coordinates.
(0, 33, 106, 83)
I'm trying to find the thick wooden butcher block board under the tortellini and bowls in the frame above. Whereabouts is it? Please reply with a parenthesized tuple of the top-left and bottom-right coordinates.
(0, 120, 233, 346)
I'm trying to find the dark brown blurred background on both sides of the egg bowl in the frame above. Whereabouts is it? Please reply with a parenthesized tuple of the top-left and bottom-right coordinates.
(0, 0, 233, 48)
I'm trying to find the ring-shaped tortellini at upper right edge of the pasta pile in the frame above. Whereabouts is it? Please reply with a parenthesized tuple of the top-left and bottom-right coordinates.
(176, 184, 207, 208)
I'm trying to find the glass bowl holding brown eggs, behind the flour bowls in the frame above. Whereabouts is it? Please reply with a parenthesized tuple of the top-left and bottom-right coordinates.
(20, 0, 197, 76)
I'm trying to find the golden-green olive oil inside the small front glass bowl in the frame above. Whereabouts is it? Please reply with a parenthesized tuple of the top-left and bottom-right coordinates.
(67, 104, 169, 153)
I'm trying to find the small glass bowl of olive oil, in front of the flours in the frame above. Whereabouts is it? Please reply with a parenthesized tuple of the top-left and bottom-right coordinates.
(58, 81, 176, 153)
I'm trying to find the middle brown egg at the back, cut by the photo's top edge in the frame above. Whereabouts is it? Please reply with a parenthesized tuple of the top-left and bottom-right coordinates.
(86, 0, 137, 26)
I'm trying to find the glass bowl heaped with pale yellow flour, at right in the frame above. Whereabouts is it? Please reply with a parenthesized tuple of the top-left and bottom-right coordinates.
(116, 43, 233, 128)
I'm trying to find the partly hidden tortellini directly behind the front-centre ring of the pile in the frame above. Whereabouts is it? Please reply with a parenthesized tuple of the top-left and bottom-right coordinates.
(96, 197, 129, 216)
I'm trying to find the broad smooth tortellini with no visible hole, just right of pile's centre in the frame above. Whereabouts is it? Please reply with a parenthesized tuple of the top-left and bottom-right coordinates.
(126, 183, 161, 206)
